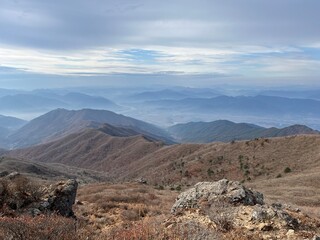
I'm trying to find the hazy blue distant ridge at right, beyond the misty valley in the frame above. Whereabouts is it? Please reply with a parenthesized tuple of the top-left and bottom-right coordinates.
(146, 95, 320, 118)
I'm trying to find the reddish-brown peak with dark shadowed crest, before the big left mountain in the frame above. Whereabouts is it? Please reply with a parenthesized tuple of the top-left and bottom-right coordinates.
(6, 125, 163, 173)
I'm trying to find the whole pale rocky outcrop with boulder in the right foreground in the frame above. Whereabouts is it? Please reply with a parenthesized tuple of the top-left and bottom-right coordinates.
(166, 179, 320, 239)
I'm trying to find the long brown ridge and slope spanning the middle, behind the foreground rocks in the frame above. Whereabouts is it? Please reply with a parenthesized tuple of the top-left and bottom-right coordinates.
(4, 133, 320, 191)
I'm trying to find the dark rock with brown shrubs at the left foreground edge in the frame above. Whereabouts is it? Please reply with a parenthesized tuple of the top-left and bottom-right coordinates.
(0, 173, 78, 217)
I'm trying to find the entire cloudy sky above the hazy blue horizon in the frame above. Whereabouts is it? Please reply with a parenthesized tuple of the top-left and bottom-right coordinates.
(0, 0, 320, 89)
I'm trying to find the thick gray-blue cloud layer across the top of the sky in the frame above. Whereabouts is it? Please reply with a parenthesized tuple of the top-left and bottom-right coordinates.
(0, 0, 320, 50)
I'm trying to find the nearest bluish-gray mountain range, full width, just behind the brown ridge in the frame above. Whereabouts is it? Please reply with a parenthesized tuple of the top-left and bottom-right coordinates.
(0, 106, 319, 149)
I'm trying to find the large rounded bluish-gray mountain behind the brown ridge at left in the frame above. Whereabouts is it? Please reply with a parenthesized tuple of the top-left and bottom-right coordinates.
(7, 109, 170, 148)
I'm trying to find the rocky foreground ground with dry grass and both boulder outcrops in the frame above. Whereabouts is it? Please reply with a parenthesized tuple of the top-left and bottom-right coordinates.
(0, 173, 320, 240)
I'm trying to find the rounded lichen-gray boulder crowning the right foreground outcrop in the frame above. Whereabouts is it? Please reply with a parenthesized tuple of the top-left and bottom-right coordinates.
(171, 179, 264, 213)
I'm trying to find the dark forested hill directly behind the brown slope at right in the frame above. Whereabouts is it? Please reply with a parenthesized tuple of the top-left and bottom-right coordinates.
(168, 120, 320, 143)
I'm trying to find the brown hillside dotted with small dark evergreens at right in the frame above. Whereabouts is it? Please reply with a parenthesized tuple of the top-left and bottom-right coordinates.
(116, 135, 320, 184)
